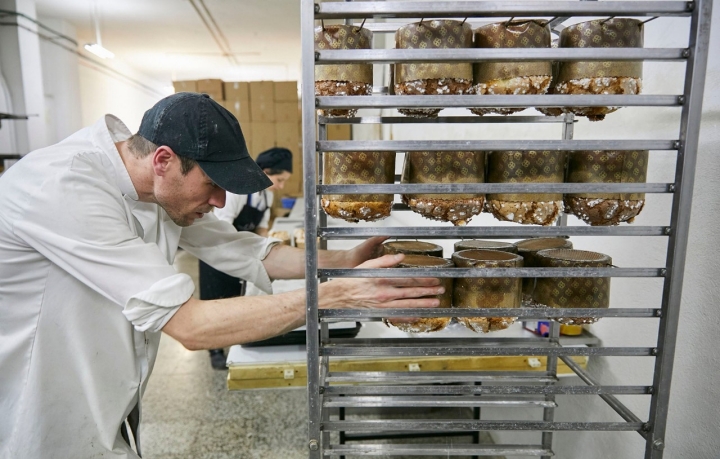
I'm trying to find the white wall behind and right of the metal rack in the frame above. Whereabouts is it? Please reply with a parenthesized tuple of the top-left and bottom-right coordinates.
(354, 7, 720, 459)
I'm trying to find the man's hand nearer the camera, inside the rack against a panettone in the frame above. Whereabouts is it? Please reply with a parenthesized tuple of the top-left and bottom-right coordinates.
(318, 253, 445, 309)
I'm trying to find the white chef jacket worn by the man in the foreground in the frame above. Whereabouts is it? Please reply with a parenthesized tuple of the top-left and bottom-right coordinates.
(0, 115, 273, 459)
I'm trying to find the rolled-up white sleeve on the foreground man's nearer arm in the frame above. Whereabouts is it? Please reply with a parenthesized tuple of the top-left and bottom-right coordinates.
(13, 161, 194, 331)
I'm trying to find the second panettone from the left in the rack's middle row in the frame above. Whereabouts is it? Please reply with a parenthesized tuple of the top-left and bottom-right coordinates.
(401, 151, 485, 225)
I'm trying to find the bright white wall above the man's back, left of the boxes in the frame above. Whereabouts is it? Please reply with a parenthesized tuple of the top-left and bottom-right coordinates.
(0, 0, 167, 154)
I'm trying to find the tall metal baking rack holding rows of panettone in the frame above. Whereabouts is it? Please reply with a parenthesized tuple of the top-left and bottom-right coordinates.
(301, 0, 712, 459)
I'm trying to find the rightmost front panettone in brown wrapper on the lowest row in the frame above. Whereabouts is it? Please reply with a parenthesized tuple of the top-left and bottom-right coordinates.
(533, 249, 612, 325)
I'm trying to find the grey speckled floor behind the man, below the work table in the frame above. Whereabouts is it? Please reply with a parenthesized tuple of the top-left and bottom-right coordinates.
(141, 252, 501, 459)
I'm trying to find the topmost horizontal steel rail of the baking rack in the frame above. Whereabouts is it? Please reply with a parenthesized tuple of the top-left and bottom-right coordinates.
(315, 0, 694, 19)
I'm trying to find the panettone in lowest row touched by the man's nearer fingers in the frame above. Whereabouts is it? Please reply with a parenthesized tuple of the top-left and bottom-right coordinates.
(383, 254, 455, 333)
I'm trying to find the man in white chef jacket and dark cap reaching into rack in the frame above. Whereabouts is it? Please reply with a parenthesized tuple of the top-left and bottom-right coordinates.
(0, 93, 441, 459)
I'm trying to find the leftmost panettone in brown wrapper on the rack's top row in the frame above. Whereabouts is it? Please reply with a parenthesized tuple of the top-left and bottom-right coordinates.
(315, 25, 373, 85)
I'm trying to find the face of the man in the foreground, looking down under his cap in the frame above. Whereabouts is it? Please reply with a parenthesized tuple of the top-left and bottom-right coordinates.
(155, 157, 225, 227)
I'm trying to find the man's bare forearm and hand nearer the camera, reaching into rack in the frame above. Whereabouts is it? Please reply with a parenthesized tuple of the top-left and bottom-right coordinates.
(163, 255, 444, 350)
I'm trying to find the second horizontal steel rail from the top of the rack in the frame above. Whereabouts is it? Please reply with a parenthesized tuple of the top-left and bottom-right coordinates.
(315, 48, 690, 63)
